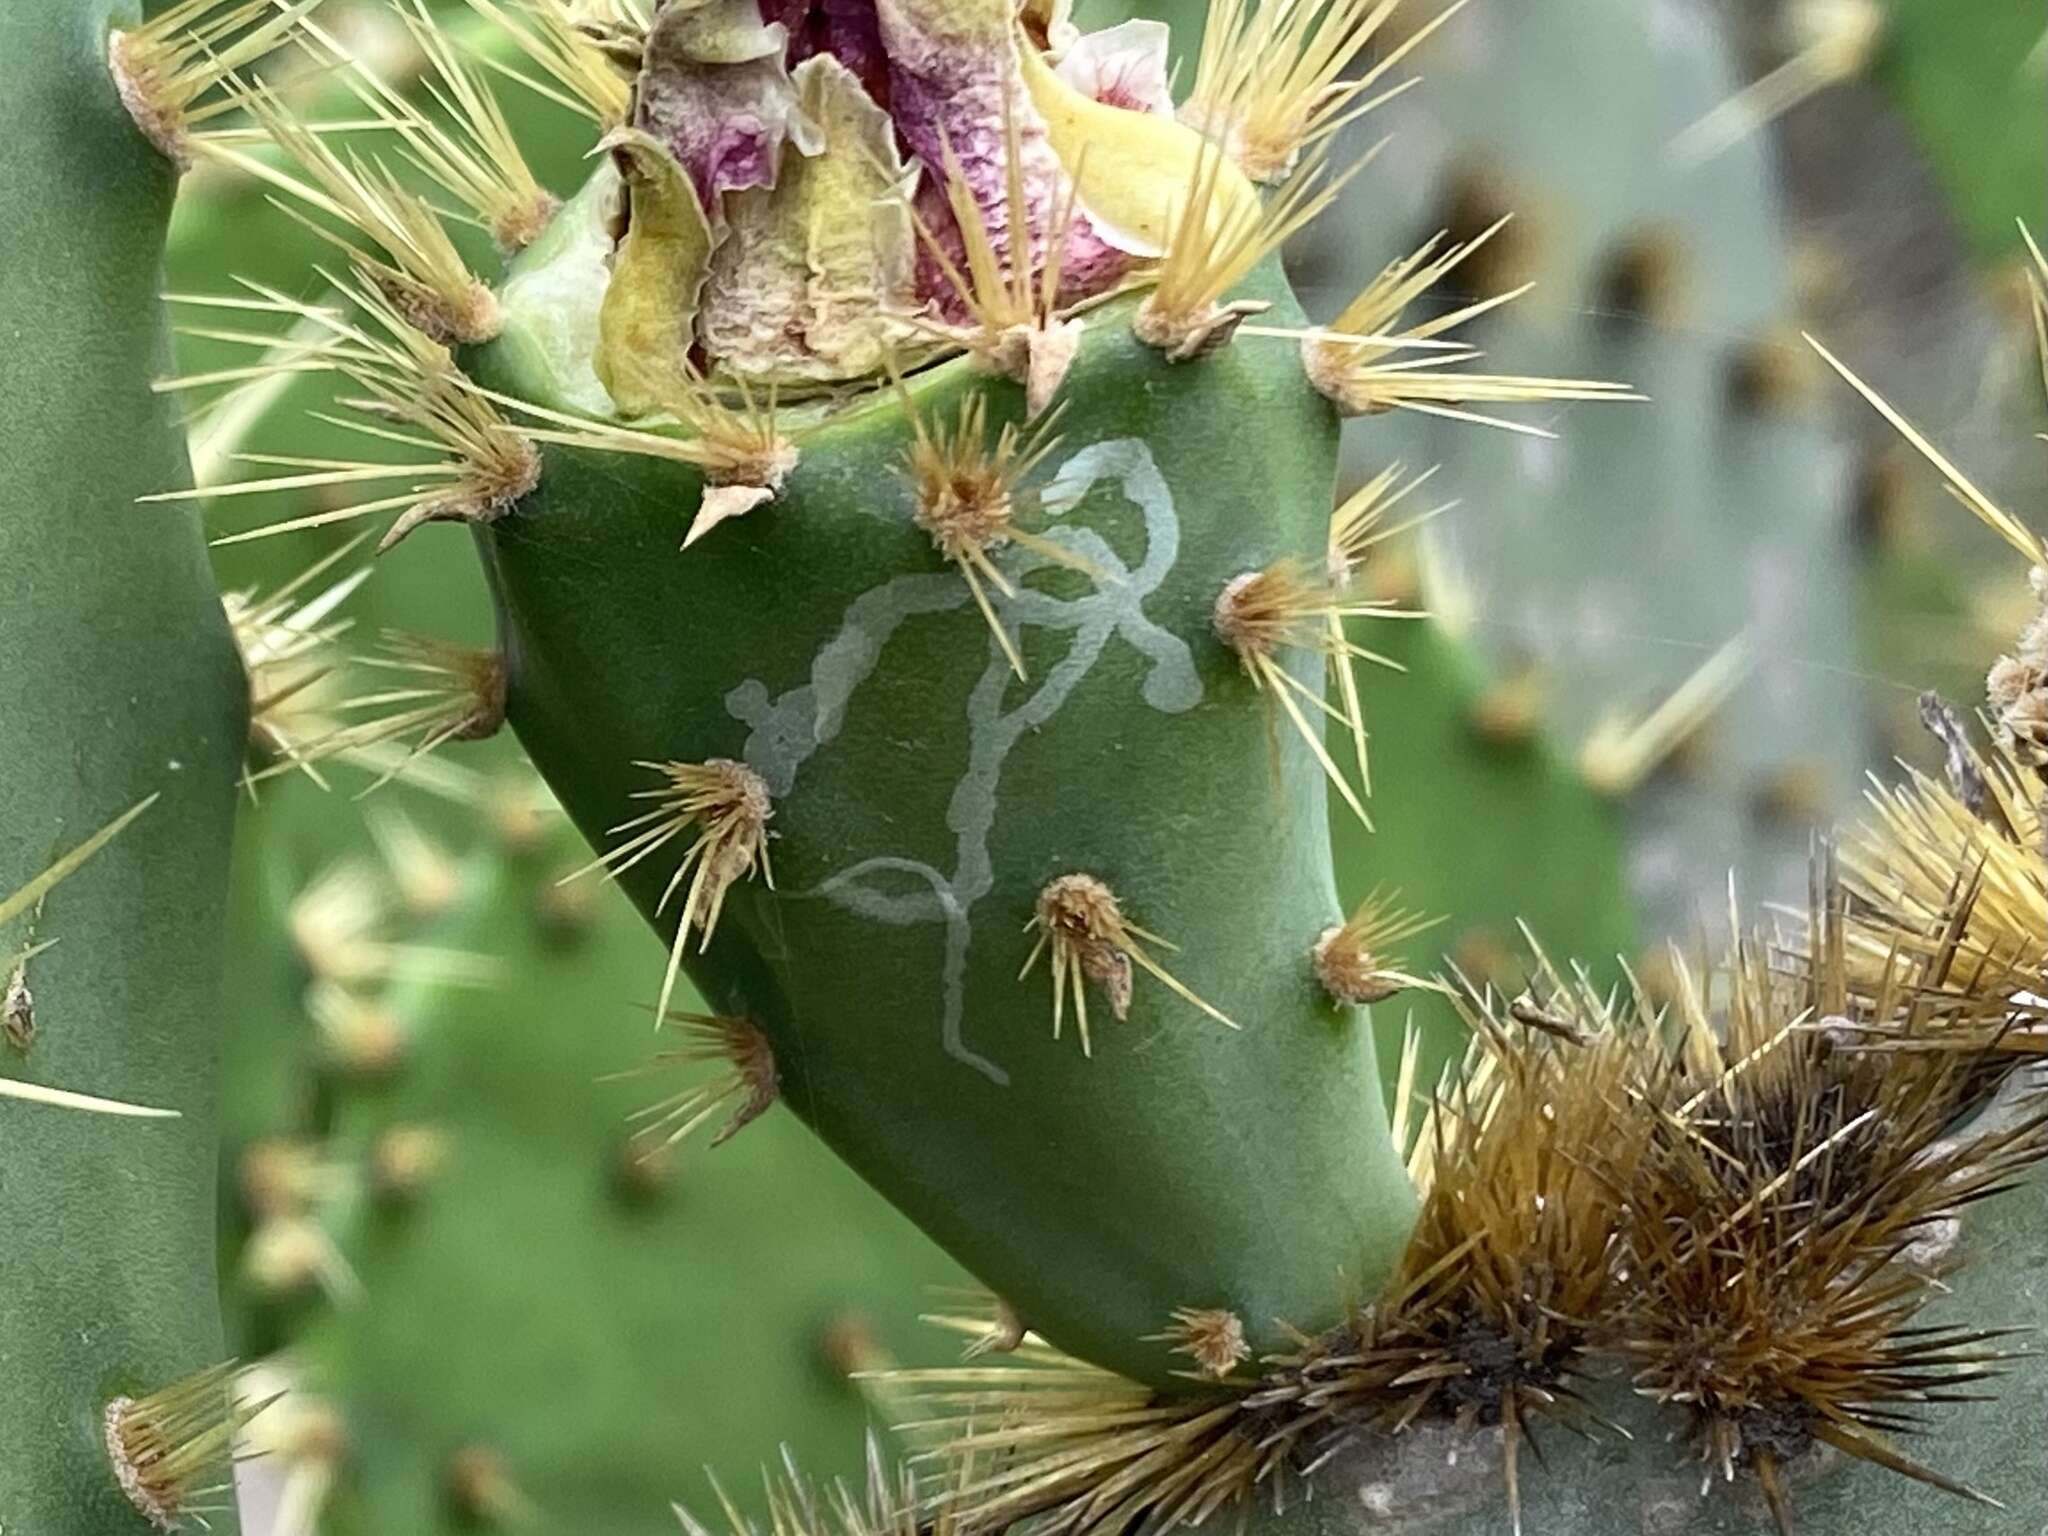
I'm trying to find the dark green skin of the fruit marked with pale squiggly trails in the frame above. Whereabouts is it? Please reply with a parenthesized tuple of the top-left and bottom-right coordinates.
(475, 231, 1411, 1384)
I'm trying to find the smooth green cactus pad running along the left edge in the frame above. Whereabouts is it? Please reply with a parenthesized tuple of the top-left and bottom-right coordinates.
(0, 0, 246, 1536)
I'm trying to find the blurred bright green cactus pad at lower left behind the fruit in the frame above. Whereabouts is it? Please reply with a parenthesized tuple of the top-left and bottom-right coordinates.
(264, 836, 961, 1536)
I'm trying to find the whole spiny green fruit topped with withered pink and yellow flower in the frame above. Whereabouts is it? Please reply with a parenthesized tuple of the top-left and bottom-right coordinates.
(151, 0, 1616, 1384)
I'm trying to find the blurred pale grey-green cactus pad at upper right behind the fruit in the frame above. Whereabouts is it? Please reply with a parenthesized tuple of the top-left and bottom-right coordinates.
(1290, 0, 1868, 934)
